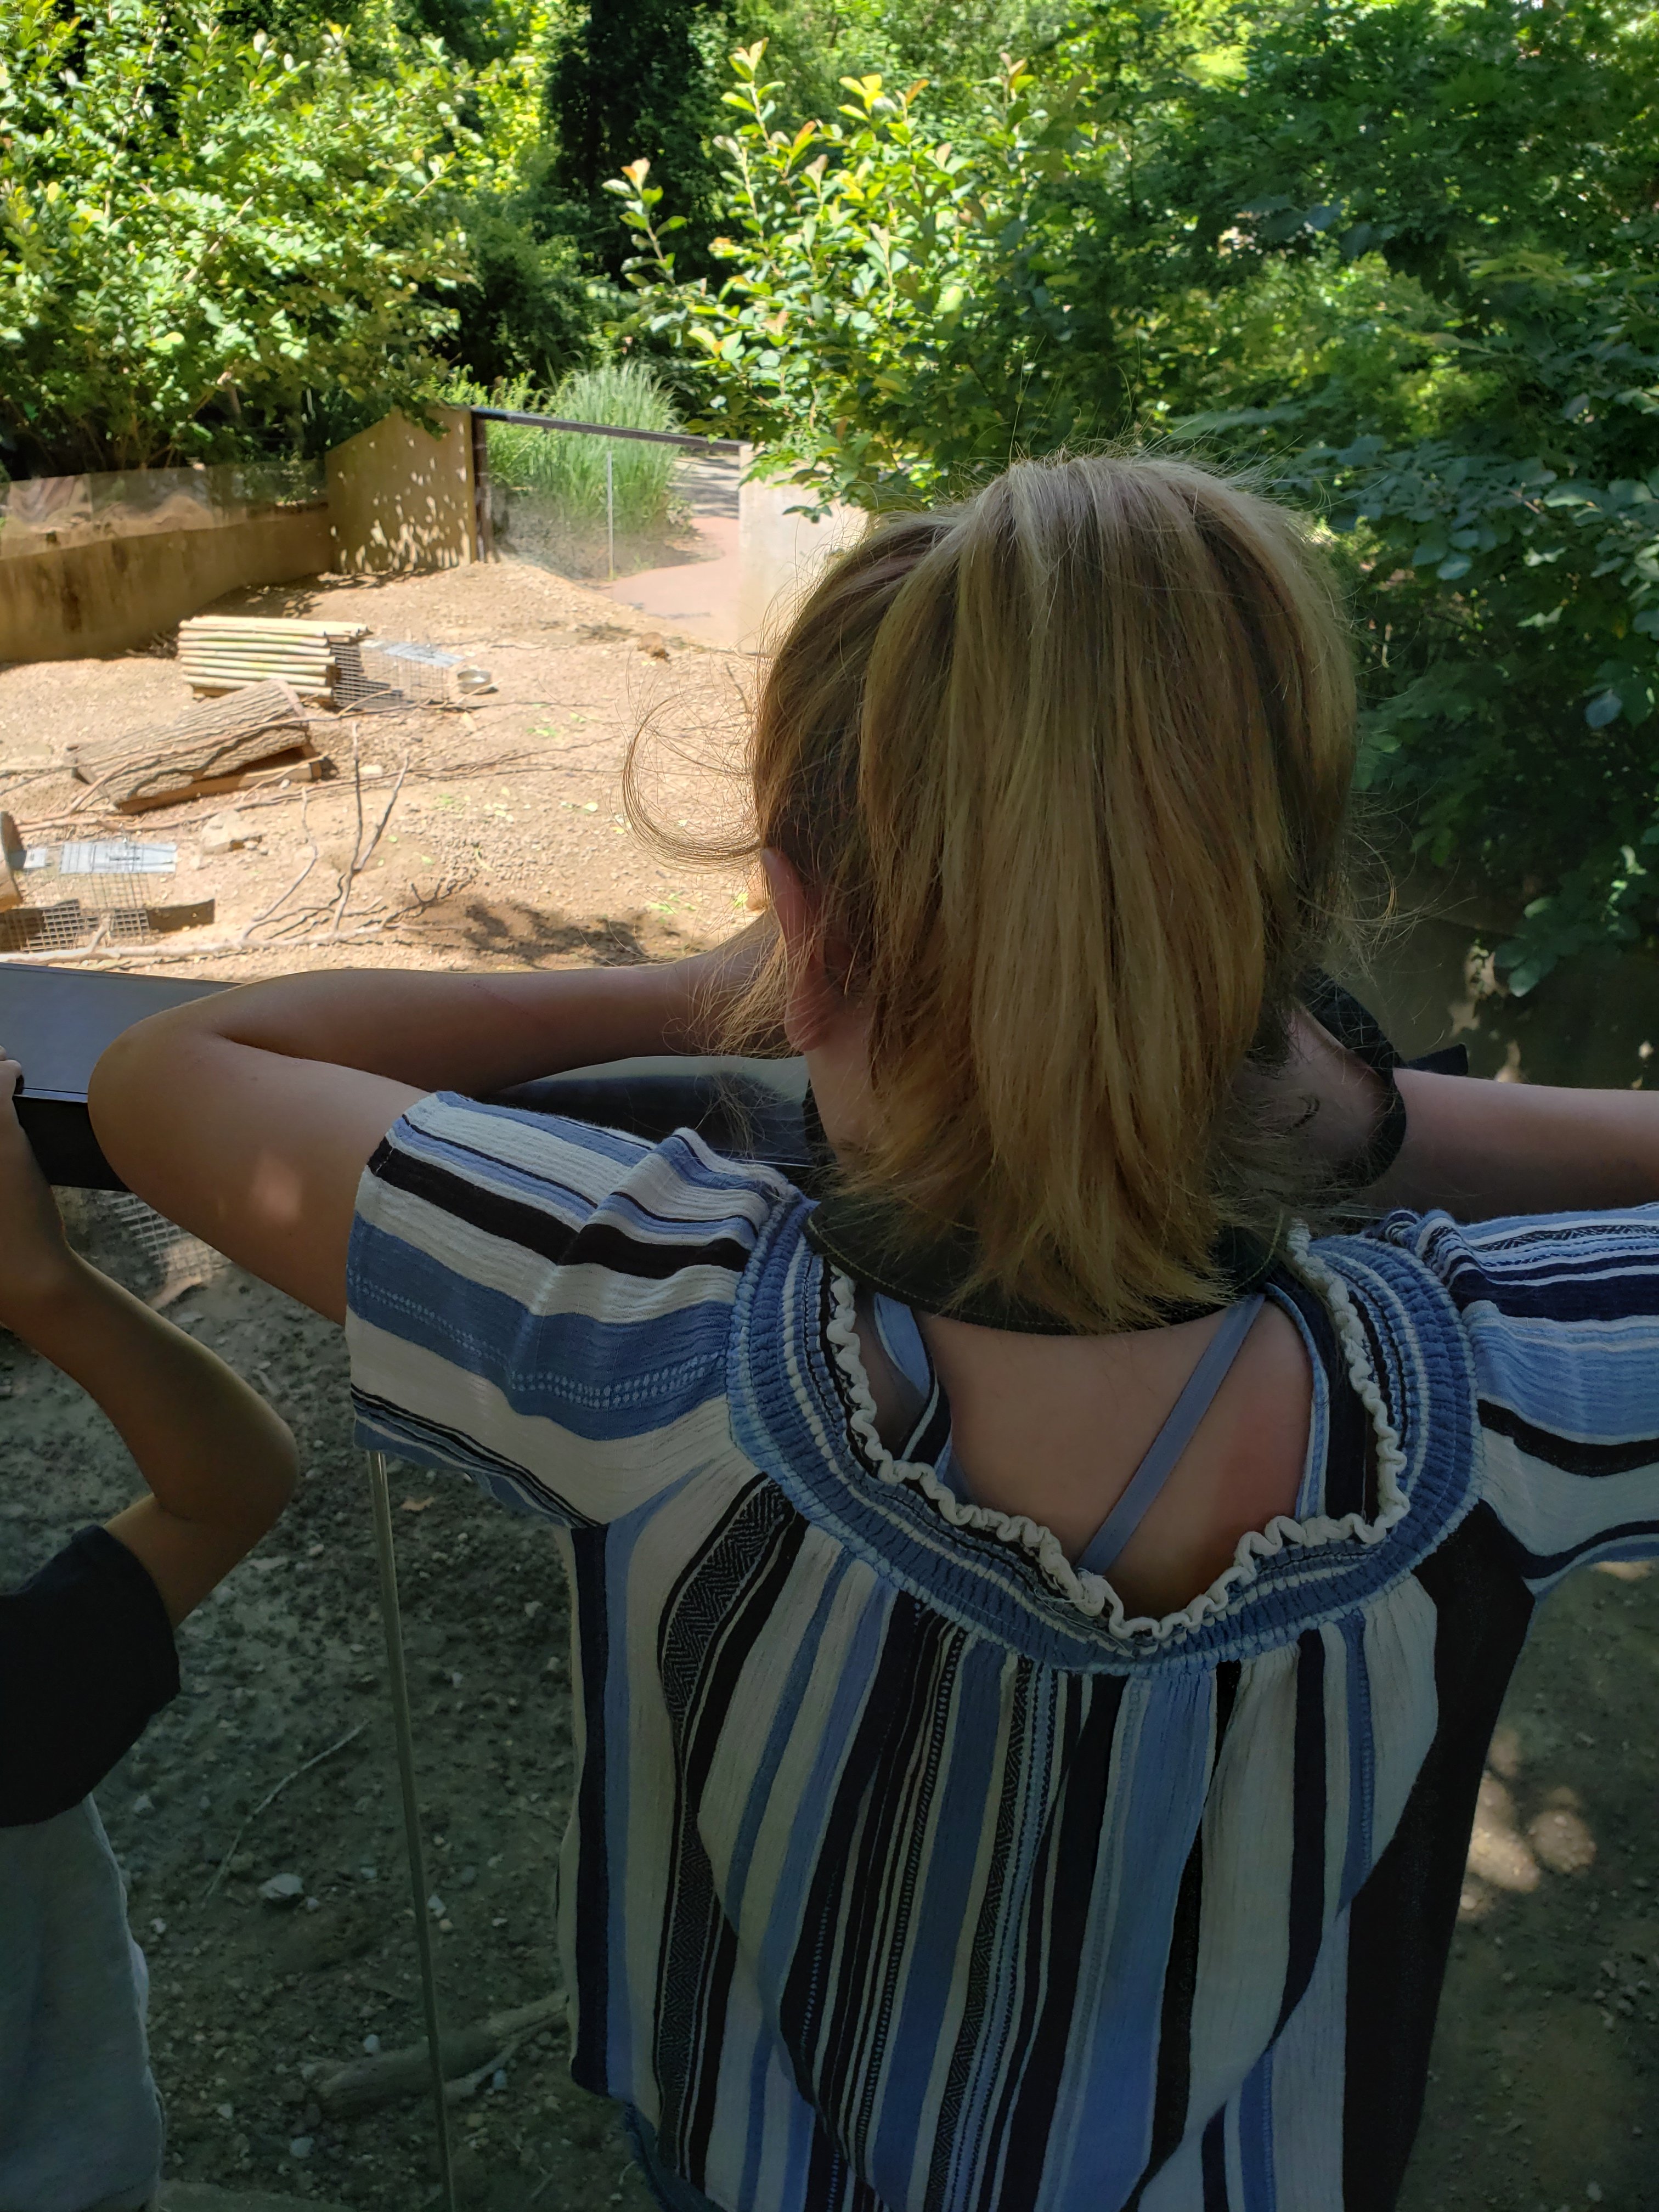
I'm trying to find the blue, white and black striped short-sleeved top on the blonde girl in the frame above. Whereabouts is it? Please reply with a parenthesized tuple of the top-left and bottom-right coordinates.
(349, 1097, 1659, 2212)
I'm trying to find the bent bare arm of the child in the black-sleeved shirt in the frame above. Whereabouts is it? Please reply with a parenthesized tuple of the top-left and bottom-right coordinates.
(0, 1051, 296, 1626)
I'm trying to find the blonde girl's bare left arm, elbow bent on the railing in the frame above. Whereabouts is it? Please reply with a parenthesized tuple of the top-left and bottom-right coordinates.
(88, 918, 772, 1321)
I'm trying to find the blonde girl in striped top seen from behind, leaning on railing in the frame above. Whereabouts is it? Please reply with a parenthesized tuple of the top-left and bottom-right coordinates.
(93, 460, 1659, 2212)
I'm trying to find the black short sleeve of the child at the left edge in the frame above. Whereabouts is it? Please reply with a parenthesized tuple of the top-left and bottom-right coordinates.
(0, 1528, 179, 1827)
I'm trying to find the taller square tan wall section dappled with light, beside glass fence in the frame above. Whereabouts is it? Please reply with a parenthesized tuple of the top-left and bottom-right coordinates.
(328, 407, 478, 575)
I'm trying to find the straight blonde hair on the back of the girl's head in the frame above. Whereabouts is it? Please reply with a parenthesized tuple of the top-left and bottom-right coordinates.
(635, 440, 1354, 1329)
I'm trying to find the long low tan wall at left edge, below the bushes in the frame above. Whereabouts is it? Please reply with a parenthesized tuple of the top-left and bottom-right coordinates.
(0, 506, 334, 662)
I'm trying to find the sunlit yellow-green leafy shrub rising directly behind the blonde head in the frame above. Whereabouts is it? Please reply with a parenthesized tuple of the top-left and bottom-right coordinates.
(611, 47, 1092, 504)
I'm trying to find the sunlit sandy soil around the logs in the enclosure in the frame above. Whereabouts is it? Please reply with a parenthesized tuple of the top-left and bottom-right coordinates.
(0, 562, 754, 980)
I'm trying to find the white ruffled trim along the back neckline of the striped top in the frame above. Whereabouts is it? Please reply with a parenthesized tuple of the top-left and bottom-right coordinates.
(825, 1221, 1409, 1644)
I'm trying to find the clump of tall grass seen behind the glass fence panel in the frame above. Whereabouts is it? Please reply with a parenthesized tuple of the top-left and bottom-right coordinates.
(447, 360, 679, 533)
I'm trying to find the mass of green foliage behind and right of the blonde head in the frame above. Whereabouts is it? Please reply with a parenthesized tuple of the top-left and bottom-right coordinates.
(611, 0, 1659, 989)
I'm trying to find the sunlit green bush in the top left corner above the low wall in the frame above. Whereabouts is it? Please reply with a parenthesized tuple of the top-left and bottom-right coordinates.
(0, 0, 479, 471)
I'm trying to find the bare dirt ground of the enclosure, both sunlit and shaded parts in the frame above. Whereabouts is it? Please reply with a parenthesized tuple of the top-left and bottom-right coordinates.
(0, 564, 1659, 2212)
